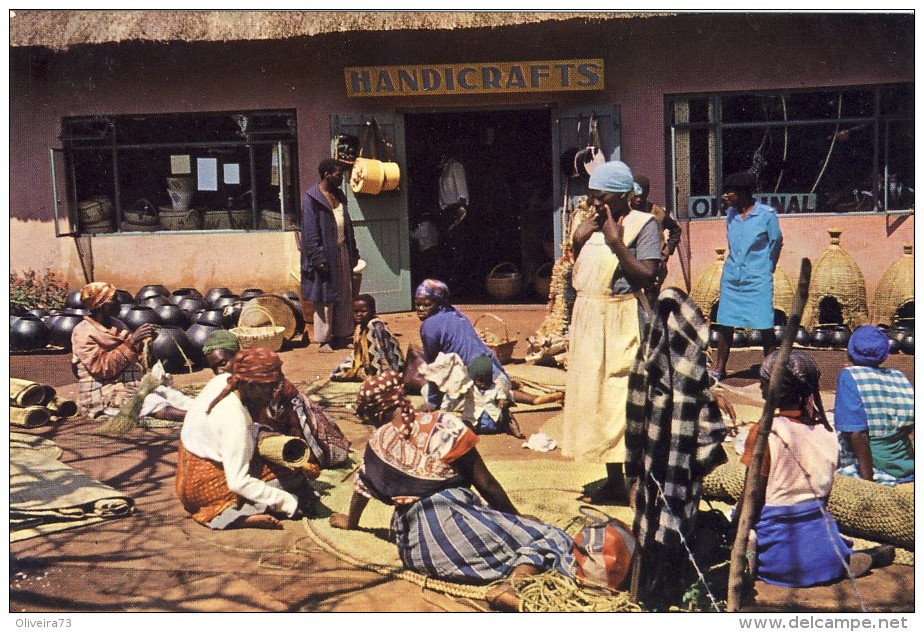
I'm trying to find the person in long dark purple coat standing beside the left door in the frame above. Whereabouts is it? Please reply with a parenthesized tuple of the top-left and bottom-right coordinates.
(301, 158, 359, 353)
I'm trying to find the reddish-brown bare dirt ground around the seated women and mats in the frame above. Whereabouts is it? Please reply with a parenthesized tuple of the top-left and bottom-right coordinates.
(9, 305, 915, 613)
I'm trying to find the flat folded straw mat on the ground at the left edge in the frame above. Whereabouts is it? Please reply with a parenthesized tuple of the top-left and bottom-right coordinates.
(10, 432, 135, 542)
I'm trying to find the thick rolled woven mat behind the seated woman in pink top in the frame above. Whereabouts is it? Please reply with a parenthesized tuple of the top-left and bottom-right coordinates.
(703, 443, 914, 551)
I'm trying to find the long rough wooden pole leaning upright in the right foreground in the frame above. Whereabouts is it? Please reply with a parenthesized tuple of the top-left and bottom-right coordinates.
(727, 259, 812, 612)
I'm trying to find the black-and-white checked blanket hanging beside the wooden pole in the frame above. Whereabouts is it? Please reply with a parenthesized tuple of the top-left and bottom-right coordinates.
(626, 288, 727, 548)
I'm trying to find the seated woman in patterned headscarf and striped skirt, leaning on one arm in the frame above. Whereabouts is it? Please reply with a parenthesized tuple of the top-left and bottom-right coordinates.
(330, 371, 573, 610)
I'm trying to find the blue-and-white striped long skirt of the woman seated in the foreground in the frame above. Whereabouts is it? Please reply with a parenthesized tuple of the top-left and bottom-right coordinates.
(391, 487, 574, 584)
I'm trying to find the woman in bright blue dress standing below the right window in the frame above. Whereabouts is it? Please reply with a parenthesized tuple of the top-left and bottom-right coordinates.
(710, 171, 783, 380)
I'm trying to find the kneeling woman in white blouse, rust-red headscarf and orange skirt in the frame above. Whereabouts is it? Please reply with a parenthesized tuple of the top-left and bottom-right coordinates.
(176, 347, 311, 529)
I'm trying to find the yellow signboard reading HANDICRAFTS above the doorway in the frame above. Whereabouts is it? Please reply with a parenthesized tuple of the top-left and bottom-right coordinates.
(343, 59, 604, 97)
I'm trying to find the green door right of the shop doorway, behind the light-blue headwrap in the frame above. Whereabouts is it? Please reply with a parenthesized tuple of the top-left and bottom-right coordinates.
(552, 105, 622, 257)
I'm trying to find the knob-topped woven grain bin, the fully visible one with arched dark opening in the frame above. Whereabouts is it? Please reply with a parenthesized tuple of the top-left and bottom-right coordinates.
(802, 228, 869, 331)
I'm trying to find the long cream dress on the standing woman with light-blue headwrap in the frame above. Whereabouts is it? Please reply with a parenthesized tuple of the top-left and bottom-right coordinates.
(561, 216, 650, 463)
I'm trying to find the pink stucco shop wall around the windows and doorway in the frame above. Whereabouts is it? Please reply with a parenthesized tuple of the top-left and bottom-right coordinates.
(9, 14, 914, 298)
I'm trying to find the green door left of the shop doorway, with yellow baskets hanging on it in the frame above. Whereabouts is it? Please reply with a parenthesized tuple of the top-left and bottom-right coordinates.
(330, 114, 411, 313)
